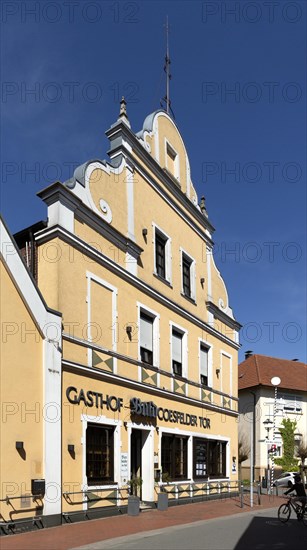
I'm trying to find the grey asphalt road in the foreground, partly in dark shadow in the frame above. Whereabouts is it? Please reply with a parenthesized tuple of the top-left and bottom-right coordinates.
(73, 508, 307, 550)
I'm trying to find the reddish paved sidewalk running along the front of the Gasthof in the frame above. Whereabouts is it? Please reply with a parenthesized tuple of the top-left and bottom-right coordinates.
(0, 495, 284, 550)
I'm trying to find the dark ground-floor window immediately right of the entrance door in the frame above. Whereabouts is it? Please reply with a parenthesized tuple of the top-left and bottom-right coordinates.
(162, 435, 188, 481)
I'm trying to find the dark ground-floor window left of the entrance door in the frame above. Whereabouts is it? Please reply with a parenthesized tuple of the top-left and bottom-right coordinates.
(86, 424, 114, 485)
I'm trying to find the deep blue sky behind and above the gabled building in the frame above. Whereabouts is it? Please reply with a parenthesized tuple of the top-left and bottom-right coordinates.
(0, 0, 306, 361)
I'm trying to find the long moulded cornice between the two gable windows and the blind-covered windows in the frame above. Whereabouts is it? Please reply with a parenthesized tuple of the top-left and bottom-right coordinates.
(35, 226, 240, 350)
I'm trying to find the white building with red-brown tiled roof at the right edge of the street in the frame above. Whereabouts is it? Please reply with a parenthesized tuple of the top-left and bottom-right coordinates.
(238, 352, 307, 480)
